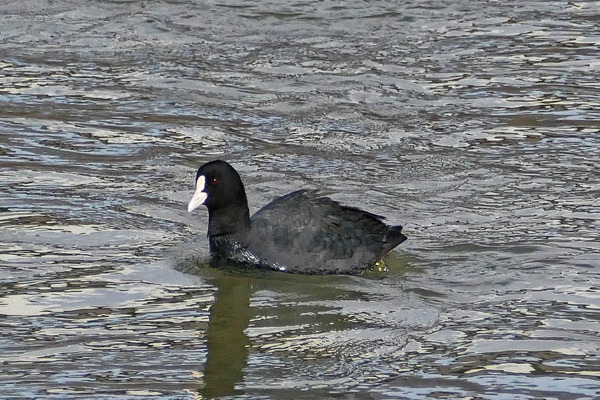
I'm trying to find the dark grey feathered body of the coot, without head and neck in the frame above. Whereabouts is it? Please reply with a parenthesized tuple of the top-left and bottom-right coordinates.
(239, 190, 406, 274)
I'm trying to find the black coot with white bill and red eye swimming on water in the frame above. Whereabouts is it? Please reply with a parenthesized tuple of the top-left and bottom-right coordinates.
(188, 160, 406, 274)
